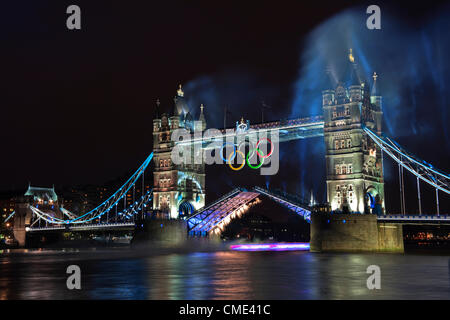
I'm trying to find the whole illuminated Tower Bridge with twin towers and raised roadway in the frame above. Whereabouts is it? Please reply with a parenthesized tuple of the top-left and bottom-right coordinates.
(8, 50, 450, 251)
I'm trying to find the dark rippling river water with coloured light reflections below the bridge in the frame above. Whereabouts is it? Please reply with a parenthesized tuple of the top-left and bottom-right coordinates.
(0, 248, 450, 299)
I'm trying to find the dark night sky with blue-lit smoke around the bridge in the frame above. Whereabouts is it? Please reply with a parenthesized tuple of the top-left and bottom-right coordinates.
(0, 0, 450, 212)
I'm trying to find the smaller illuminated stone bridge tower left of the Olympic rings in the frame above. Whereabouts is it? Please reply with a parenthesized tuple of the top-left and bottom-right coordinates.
(153, 85, 206, 219)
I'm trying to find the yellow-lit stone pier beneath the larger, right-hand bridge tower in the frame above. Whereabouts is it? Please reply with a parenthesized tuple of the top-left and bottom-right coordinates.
(310, 213, 404, 252)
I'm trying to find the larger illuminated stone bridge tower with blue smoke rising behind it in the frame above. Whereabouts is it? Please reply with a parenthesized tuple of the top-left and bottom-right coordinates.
(322, 49, 385, 214)
